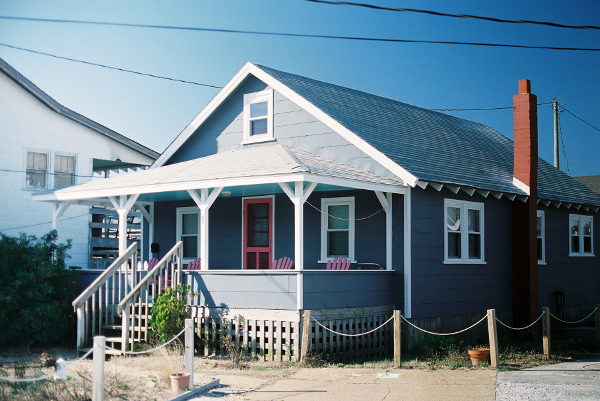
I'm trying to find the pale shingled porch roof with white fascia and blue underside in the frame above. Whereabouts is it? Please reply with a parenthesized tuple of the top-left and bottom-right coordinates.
(33, 144, 405, 202)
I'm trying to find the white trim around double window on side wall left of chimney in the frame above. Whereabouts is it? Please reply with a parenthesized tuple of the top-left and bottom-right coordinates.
(443, 199, 486, 265)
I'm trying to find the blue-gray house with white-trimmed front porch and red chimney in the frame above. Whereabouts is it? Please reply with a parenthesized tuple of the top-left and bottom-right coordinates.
(35, 63, 600, 356)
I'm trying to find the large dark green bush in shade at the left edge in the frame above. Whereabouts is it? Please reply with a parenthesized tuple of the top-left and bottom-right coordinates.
(0, 231, 77, 346)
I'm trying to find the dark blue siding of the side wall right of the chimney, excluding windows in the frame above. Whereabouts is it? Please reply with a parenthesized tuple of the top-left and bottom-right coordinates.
(538, 205, 600, 307)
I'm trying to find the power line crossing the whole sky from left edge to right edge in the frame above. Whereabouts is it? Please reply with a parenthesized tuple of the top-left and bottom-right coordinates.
(0, 15, 600, 51)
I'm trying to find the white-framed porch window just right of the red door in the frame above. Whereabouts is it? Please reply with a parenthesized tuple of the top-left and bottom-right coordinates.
(321, 196, 354, 261)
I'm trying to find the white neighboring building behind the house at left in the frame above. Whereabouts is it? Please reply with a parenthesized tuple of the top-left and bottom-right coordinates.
(0, 59, 159, 269)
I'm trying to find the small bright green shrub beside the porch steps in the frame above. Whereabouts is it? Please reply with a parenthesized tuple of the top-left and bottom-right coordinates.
(150, 284, 197, 343)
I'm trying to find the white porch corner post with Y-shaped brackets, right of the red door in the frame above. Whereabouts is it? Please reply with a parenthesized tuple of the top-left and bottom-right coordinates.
(279, 181, 317, 310)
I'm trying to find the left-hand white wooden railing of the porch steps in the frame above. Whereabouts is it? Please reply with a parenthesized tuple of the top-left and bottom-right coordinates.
(73, 242, 138, 349)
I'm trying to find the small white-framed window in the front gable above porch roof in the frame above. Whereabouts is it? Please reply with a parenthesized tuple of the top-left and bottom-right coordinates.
(244, 89, 273, 143)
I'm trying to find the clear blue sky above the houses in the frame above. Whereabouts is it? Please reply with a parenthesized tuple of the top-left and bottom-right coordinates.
(0, 0, 600, 176)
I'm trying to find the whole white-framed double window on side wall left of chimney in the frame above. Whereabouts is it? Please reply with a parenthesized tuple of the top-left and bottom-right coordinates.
(444, 199, 485, 263)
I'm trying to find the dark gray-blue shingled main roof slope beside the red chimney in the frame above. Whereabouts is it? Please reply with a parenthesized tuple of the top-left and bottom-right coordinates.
(257, 65, 600, 206)
